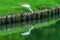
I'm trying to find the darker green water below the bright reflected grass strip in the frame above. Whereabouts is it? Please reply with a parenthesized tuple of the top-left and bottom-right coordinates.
(0, 21, 60, 40)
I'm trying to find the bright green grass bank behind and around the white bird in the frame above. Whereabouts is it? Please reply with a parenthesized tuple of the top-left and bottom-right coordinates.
(0, 0, 60, 16)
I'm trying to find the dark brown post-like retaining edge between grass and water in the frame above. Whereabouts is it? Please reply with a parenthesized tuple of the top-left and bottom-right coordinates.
(0, 8, 60, 25)
